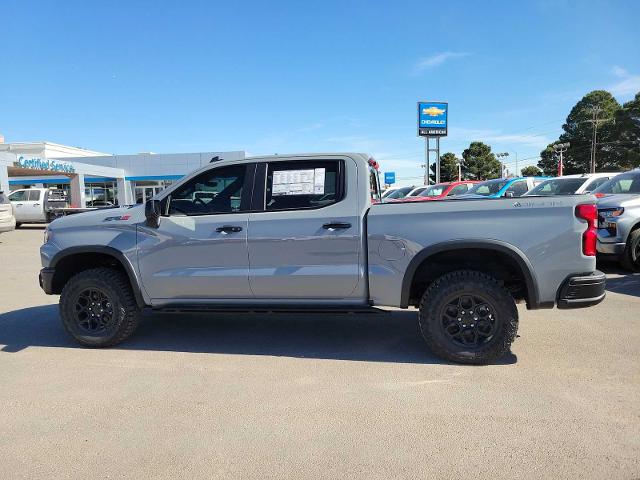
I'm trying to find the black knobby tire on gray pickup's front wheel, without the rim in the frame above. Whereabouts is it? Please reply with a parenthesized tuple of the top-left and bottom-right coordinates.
(59, 268, 141, 348)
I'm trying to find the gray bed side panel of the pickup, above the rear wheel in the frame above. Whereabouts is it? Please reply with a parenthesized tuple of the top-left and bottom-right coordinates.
(367, 196, 596, 306)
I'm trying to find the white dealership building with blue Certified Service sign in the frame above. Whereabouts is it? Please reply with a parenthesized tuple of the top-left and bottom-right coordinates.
(0, 136, 245, 207)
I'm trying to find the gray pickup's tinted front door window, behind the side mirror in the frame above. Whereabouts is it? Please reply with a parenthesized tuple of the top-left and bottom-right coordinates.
(169, 165, 247, 215)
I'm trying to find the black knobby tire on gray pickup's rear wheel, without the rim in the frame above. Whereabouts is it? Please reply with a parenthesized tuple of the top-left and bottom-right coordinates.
(418, 270, 518, 365)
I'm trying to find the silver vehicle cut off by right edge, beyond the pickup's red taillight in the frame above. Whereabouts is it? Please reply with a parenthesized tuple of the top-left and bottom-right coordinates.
(593, 169, 640, 271)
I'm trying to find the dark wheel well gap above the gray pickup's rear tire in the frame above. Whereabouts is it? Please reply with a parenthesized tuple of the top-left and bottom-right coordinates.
(408, 248, 535, 305)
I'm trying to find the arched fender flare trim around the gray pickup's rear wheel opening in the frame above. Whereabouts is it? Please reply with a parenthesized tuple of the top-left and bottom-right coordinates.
(400, 239, 542, 309)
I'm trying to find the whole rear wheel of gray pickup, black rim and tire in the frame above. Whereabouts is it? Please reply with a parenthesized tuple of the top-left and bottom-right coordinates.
(418, 270, 518, 364)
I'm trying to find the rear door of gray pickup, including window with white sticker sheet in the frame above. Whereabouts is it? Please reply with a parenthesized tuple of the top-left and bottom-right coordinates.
(248, 158, 364, 301)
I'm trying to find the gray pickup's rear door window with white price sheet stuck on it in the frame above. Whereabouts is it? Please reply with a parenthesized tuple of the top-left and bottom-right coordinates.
(265, 160, 342, 210)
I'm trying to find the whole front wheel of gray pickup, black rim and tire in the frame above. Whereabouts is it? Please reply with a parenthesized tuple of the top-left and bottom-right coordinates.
(60, 268, 141, 348)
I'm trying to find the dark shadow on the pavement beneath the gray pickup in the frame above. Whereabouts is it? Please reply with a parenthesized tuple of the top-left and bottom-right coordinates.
(0, 305, 517, 365)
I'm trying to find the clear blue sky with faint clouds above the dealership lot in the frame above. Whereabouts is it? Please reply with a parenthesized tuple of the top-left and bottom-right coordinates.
(0, 0, 640, 182)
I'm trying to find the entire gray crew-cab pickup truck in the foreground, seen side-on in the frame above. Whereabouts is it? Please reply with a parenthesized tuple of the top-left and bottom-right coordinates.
(40, 153, 605, 363)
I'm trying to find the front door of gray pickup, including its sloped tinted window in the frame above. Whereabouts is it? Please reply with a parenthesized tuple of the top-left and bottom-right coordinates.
(138, 164, 255, 301)
